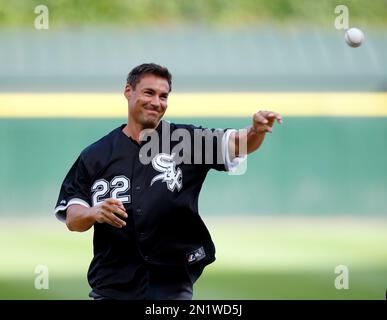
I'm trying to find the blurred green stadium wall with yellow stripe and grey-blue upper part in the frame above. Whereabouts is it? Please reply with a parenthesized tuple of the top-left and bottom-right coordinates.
(0, 1, 387, 217)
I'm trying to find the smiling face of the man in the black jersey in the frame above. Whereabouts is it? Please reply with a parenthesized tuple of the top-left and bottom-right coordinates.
(125, 75, 169, 129)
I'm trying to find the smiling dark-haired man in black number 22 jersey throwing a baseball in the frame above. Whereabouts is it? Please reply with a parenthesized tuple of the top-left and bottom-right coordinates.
(55, 63, 282, 299)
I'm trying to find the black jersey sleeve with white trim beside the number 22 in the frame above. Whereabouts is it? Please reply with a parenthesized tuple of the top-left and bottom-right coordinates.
(54, 156, 91, 221)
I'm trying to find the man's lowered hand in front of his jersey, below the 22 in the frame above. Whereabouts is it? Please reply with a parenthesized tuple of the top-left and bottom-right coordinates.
(91, 198, 128, 228)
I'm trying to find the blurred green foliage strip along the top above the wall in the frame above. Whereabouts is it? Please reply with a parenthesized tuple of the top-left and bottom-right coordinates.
(0, 0, 387, 27)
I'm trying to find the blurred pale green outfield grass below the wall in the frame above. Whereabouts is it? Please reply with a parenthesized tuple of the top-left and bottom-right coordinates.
(0, 217, 387, 299)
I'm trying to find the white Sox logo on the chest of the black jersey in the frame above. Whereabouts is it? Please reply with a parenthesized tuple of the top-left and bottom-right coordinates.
(151, 153, 183, 192)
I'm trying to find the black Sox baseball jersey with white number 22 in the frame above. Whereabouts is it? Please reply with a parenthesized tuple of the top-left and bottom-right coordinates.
(55, 121, 242, 298)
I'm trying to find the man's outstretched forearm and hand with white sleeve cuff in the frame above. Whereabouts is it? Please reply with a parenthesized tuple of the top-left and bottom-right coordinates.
(228, 111, 282, 157)
